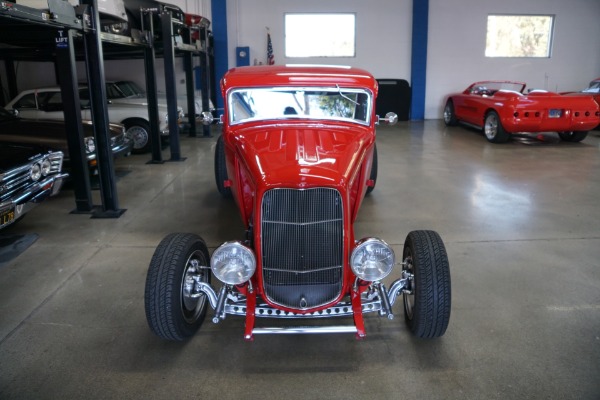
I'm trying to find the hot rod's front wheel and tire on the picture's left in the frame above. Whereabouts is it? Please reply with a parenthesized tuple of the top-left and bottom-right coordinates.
(144, 233, 210, 341)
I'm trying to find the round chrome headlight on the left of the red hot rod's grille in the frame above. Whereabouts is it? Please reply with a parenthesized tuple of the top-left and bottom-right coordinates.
(210, 242, 256, 285)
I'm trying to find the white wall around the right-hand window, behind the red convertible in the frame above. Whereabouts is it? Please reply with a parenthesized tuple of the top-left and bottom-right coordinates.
(425, 0, 600, 119)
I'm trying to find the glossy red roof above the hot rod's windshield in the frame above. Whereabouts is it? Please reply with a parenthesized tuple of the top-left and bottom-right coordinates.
(221, 65, 377, 95)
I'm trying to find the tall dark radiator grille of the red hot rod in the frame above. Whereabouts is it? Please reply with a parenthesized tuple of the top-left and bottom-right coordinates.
(261, 188, 344, 309)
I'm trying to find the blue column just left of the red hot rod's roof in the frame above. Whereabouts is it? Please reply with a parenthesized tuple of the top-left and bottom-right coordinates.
(211, 0, 229, 114)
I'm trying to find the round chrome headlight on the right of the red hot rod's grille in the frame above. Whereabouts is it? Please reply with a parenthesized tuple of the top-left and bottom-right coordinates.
(350, 238, 396, 282)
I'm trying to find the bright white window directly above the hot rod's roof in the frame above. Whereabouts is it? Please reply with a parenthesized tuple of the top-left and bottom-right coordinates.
(284, 13, 356, 58)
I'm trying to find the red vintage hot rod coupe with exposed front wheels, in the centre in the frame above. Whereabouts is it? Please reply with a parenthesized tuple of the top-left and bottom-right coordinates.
(145, 66, 451, 340)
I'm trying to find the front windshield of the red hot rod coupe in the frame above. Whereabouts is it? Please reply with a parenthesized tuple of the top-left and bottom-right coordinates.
(228, 87, 371, 125)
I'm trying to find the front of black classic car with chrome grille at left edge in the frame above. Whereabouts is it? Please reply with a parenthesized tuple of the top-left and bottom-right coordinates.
(0, 143, 68, 229)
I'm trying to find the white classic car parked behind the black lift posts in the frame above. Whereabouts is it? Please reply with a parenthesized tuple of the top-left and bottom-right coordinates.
(5, 87, 183, 154)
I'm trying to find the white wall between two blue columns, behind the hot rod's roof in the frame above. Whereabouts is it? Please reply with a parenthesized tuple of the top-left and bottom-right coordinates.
(227, 0, 412, 80)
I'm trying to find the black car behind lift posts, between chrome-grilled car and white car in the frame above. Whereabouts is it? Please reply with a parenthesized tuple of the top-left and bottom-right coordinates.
(0, 107, 133, 173)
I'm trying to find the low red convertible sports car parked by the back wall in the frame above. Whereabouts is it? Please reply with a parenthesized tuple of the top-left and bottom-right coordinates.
(444, 81, 600, 143)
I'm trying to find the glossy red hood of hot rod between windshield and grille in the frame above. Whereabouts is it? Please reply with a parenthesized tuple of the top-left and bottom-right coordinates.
(229, 123, 373, 188)
